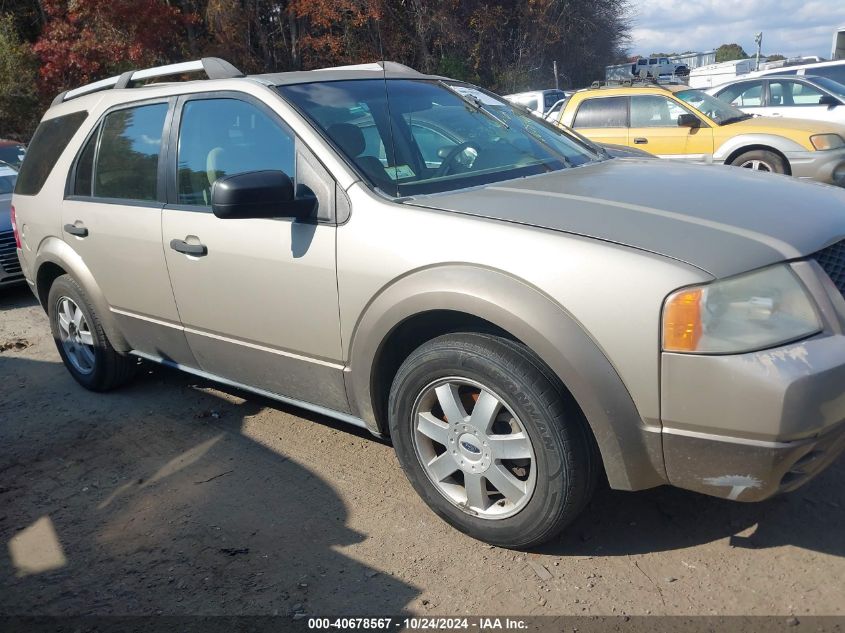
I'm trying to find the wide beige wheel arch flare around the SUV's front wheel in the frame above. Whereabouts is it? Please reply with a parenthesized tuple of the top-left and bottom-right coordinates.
(347, 264, 666, 490)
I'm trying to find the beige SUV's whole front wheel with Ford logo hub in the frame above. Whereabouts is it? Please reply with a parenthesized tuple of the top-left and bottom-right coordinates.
(389, 333, 596, 548)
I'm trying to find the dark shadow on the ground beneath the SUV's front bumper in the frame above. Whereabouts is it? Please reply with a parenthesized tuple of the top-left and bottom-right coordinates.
(539, 459, 845, 557)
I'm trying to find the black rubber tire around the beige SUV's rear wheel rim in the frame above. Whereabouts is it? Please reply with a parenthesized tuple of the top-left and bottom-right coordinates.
(47, 275, 138, 391)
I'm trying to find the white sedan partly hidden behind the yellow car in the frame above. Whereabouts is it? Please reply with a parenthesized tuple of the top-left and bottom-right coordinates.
(707, 75, 845, 124)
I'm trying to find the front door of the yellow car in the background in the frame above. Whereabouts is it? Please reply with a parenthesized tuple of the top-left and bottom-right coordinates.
(628, 95, 713, 162)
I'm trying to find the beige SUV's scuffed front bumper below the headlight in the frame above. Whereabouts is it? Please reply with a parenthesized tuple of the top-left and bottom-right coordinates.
(661, 262, 845, 501)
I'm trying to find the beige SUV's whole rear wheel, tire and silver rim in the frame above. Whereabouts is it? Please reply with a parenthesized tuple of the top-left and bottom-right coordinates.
(47, 275, 138, 391)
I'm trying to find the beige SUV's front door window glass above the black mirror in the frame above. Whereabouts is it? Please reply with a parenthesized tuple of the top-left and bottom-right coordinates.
(177, 99, 296, 206)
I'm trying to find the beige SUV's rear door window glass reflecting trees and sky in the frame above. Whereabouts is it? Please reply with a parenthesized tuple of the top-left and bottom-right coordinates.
(95, 103, 167, 201)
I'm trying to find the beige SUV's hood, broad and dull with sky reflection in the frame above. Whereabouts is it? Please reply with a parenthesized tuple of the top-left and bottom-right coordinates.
(408, 159, 845, 277)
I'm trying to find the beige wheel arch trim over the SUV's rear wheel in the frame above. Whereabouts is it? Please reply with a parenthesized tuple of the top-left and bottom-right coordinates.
(35, 238, 132, 352)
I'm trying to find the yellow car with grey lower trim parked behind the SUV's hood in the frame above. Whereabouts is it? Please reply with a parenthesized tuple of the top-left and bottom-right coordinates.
(558, 83, 845, 181)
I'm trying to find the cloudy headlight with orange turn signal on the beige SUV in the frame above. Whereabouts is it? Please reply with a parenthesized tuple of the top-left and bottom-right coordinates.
(663, 264, 821, 354)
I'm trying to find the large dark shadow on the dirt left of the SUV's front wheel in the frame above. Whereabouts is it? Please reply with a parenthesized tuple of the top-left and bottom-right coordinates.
(0, 354, 419, 619)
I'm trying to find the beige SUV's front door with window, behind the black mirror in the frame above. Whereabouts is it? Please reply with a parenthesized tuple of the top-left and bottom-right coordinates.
(163, 95, 348, 411)
